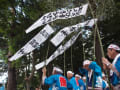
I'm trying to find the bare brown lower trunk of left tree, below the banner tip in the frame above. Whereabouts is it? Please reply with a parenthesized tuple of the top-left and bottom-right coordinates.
(7, 61, 17, 90)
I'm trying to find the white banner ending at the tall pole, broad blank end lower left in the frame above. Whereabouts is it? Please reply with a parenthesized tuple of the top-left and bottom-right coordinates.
(50, 19, 97, 46)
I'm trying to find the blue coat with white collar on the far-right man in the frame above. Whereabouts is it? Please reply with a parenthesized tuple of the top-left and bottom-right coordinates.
(110, 54, 120, 86)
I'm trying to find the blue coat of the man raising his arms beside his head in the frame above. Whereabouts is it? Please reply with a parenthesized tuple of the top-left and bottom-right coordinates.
(80, 61, 102, 88)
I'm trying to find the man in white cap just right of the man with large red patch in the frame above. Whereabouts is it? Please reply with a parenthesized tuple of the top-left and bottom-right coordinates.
(67, 71, 80, 90)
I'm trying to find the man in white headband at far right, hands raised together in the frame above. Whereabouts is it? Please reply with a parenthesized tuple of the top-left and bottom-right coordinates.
(102, 44, 120, 90)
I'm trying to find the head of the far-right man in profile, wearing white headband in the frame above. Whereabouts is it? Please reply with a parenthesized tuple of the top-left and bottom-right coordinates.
(107, 44, 120, 59)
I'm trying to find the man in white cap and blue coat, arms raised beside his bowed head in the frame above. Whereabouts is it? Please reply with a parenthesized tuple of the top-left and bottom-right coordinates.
(80, 60, 102, 90)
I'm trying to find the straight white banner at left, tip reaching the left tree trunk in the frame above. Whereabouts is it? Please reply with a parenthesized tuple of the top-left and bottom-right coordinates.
(9, 25, 54, 61)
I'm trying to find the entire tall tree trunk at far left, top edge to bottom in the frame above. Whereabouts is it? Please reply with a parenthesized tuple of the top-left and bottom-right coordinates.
(7, 0, 17, 90)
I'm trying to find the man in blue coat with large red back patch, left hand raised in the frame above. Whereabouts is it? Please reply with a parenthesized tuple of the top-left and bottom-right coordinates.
(42, 67, 72, 90)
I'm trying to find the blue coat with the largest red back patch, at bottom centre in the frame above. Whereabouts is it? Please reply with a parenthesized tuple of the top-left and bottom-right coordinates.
(44, 74, 72, 90)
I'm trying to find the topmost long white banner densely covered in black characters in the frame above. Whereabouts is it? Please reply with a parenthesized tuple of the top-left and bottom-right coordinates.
(26, 4, 88, 33)
